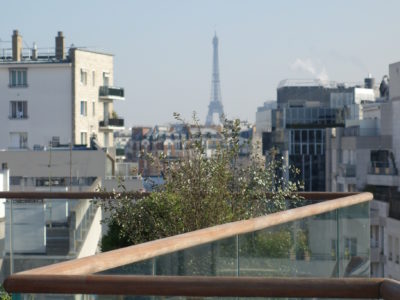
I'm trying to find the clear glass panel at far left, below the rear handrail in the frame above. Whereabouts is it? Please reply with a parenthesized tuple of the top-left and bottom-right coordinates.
(0, 198, 102, 280)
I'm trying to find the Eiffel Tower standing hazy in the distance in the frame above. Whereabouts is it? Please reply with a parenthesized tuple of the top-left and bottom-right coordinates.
(206, 33, 224, 126)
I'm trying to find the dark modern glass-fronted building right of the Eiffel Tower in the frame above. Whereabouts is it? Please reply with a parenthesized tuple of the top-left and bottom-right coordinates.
(257, 80, 375, 191)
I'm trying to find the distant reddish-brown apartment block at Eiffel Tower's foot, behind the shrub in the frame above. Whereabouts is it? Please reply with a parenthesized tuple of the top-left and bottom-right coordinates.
(125, 122, 254, 177)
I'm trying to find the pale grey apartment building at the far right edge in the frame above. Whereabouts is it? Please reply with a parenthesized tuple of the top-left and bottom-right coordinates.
(326, 62, 400, 279)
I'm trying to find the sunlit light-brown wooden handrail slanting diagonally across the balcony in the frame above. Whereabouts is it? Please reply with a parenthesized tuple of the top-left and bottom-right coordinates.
(14, 193, 373, 279)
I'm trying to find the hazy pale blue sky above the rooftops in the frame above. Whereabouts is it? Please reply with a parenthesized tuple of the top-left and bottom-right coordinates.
(0, 0, 400, 126)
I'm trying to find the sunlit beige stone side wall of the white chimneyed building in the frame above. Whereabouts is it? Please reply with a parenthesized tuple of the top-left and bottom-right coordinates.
(74, 49, 114, 146)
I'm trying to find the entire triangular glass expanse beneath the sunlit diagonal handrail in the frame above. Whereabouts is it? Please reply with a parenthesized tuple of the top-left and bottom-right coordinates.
(98, 200, 370, 277)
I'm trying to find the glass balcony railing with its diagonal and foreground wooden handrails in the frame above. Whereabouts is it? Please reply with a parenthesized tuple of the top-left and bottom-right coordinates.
(0, 193, 400, 300)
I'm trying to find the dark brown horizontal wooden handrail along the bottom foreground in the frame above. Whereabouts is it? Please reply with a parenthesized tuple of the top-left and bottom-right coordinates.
(4, 275, 384, 300)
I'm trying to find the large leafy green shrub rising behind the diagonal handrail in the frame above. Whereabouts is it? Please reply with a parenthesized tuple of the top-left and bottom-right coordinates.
(102, 114, 300, 251)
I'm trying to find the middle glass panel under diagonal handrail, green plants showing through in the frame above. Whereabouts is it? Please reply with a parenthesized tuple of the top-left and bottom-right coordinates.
(240, 212, 337, 277)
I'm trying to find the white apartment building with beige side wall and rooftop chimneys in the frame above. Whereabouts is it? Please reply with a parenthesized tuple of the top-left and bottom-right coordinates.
(0, 30, 125, 149)
